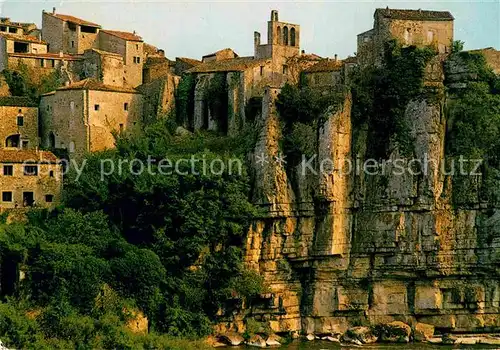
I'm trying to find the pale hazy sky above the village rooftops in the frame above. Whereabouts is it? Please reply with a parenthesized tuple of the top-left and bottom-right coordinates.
(0, 0, 500, 59)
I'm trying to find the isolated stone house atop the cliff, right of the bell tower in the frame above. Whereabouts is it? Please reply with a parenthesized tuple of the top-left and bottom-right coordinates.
(357, 8, 454, 66)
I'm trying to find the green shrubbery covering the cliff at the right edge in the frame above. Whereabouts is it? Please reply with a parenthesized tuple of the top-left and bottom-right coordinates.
(446, 52, 500, 204)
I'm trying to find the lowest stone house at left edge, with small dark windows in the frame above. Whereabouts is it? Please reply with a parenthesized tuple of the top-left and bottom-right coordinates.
(0, 149, 63, 212)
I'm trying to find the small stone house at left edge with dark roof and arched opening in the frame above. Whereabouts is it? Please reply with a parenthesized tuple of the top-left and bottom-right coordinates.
(0, 96, 39, 149)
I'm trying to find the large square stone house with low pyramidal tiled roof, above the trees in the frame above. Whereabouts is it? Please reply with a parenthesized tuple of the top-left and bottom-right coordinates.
(40, 78, 143, 158)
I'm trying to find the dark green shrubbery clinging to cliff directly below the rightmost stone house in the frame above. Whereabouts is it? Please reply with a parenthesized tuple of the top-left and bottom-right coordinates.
(352, 41, 436, 159)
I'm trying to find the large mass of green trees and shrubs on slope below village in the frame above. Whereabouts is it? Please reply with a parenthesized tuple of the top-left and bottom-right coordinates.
(0, 117, 263, 349)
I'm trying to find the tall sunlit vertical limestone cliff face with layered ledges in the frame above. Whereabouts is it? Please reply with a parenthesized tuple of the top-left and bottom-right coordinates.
(246, 56, 500, 333)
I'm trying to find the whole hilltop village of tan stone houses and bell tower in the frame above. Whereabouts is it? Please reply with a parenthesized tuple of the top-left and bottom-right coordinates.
(0, 8, 500, 210)
